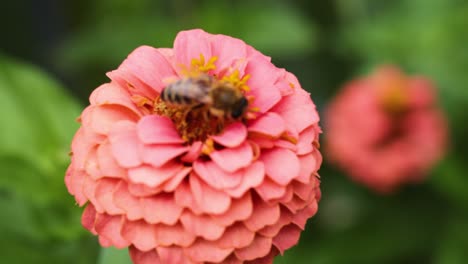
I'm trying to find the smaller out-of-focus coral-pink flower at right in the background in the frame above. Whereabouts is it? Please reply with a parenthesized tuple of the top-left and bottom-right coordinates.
(326, 66, 447, 192)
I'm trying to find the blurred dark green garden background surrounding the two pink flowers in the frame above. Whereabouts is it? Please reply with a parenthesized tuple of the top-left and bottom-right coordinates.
(0, 0, 468, 264)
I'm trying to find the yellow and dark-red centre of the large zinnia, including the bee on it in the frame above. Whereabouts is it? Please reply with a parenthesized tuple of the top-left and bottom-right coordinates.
(153, 55, 255, 144)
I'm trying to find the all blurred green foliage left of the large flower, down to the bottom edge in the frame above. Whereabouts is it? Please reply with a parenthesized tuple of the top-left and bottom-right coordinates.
(0, 57, 96, 263)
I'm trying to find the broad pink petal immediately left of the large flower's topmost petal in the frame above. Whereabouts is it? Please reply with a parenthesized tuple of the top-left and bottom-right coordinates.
(110, 46, 176, 93)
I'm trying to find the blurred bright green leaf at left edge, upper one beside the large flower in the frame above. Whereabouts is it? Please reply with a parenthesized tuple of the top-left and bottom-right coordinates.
(0, 54, 80, 174)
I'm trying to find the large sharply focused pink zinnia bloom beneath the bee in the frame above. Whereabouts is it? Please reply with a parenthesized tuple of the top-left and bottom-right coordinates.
(65, 30, 321, 264)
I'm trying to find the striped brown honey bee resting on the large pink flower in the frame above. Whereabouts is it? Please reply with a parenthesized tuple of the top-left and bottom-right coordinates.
(160, 74, 248, 120)
